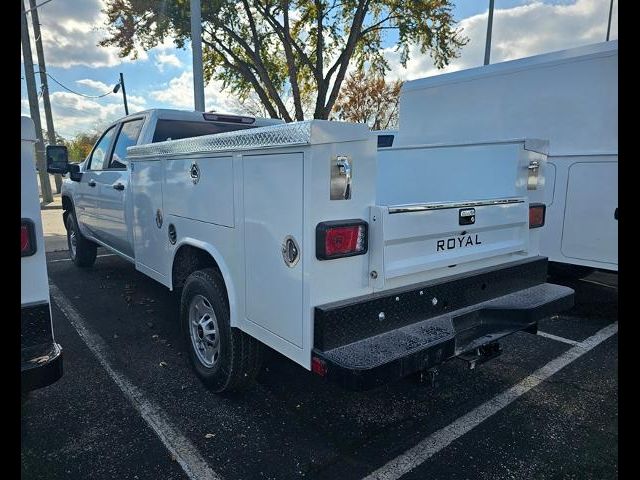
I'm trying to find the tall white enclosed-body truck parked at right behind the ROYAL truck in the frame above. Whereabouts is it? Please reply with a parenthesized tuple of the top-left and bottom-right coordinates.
(380, 41, 618, 276)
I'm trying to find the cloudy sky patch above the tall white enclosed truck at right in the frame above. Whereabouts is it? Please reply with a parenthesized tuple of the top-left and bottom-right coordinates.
(385, 0, 618, 80)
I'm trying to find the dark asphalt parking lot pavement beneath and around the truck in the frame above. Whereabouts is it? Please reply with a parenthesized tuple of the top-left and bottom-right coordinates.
(21, 246, 618, 480)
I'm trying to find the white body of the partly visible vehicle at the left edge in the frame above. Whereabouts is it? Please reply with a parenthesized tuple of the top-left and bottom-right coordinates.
(20, 117, 49, 306)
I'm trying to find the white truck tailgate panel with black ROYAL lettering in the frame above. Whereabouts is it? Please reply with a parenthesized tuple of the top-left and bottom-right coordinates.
(370, 197, 529, 280)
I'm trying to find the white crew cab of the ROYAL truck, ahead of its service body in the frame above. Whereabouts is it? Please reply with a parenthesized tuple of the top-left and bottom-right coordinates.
(62, 109, 282, 266)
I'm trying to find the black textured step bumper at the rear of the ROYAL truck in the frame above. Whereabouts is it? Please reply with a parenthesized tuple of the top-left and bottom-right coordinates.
(313, 283, 574, 390)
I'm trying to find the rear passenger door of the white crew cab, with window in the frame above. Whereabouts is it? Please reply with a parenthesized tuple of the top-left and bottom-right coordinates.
(96, 118, 144, 258)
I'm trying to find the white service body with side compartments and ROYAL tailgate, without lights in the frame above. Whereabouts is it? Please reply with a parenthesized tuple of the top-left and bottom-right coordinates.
(128, 120, 546, 368)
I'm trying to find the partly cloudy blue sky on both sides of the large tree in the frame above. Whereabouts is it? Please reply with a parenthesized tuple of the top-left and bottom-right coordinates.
(21, 0, 618, 137)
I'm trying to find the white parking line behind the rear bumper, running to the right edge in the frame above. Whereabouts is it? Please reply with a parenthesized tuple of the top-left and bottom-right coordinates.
(365, 322, 618, 480)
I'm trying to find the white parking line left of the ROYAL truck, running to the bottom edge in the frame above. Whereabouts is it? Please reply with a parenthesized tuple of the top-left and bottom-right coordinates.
(49, 284, 222, 480)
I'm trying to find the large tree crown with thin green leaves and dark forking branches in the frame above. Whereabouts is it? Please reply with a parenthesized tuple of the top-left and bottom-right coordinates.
(100, 0, 467, 121)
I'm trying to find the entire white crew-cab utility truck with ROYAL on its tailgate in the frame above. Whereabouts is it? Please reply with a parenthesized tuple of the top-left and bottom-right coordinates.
(49, 111, 573, 392)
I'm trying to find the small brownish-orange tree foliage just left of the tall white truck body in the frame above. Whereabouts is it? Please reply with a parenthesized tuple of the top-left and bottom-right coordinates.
(333, 70, 402, 130)
